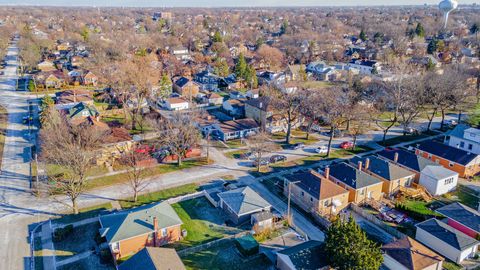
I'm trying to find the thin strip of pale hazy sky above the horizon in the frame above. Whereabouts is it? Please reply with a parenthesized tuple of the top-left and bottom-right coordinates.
(0, 0, 480, 7)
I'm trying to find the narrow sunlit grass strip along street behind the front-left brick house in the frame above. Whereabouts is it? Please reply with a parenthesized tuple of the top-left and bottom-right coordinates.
(120, 184, 198, 209)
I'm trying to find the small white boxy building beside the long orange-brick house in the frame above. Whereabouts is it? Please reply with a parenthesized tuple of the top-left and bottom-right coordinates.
(419, 165, 458, 196)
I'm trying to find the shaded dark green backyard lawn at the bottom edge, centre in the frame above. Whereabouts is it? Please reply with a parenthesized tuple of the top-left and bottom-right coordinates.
(182, 241, 273, 270)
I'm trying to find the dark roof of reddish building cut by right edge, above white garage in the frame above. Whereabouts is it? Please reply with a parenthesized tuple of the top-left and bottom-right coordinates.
(437, 202, 480, 233)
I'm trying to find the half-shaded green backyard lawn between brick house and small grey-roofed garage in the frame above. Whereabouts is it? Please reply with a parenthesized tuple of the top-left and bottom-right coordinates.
(172, 197, 233, 250)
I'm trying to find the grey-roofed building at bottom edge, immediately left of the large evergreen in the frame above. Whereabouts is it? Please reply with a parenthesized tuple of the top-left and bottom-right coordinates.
(276, 240, 330, 270)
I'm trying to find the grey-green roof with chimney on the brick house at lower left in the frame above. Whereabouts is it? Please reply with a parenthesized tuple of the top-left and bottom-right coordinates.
(100, 201, 182, 243)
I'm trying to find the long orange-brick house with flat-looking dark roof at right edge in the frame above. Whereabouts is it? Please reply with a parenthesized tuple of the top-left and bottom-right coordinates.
(415, 140, 480, 177)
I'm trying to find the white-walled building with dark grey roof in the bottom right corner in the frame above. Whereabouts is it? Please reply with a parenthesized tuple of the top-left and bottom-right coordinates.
(415, 218, 480, 263)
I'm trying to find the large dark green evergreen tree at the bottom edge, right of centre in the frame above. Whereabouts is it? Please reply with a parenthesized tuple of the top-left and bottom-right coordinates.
(325, 217, 383, 270)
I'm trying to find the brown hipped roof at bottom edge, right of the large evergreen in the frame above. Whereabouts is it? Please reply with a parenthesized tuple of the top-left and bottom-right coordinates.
(382, 236, 444, 270)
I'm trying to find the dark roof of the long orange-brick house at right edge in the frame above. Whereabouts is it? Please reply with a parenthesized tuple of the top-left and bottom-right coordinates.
(417, 140, 478, 165)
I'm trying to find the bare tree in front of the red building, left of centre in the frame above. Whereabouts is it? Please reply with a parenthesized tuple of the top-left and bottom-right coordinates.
(152, 112, 201, 166)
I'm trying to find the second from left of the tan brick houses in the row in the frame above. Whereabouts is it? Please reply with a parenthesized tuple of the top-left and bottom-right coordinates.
(324, 163, 383, 203)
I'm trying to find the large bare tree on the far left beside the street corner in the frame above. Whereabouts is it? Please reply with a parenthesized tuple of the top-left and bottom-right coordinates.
(40, 109, 103, 214)
